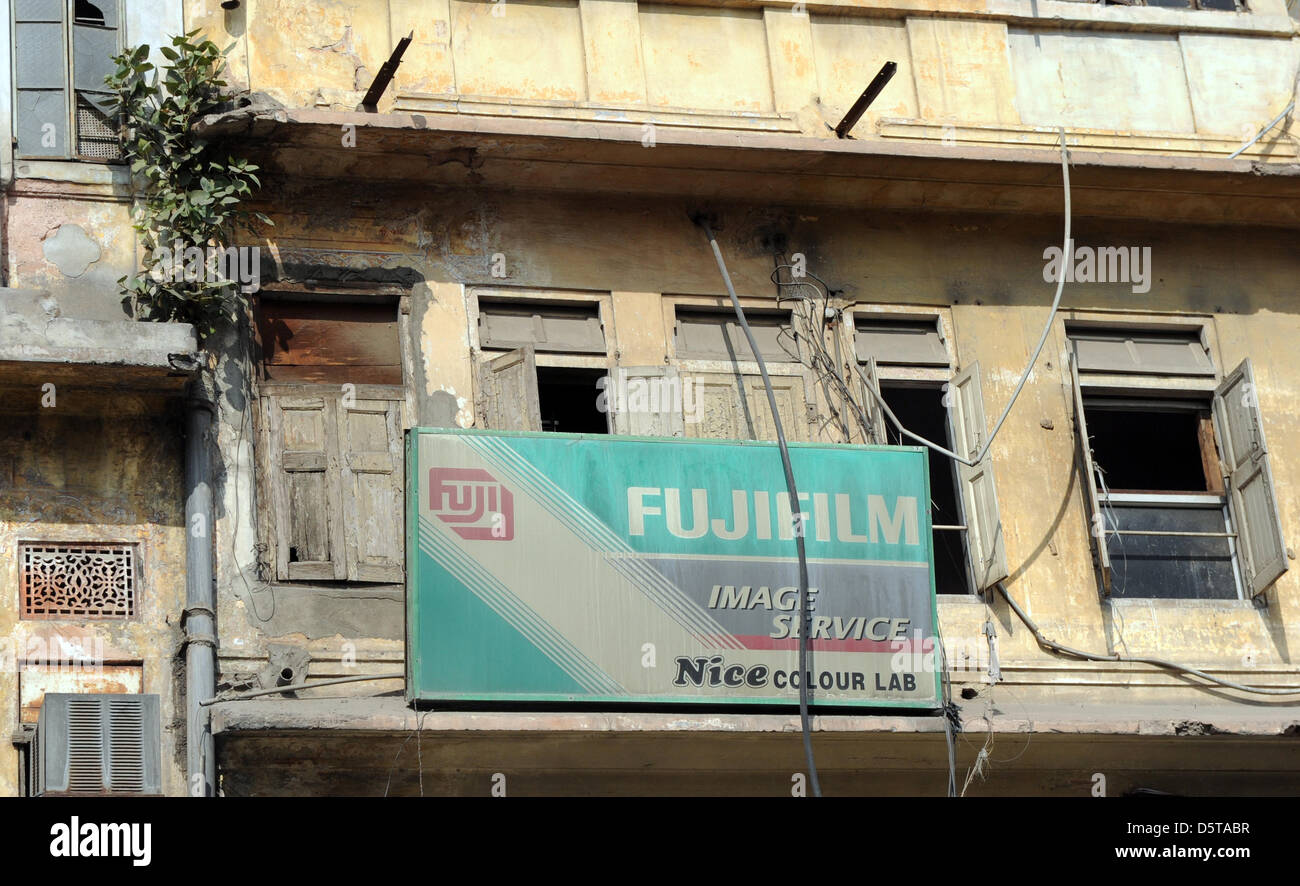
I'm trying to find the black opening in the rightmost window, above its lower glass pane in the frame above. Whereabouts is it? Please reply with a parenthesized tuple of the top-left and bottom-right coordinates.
(1084, 400, 1222, 494)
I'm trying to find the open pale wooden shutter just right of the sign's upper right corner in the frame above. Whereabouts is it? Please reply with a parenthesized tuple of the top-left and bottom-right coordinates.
(950, 361, 1010, 591)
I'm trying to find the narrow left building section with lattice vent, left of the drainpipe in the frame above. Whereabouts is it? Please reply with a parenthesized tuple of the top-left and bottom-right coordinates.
(0, 0, 198, 796)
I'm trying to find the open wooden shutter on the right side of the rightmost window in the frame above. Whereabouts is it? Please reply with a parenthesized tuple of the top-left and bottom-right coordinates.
(1214, 357, 1287, 596)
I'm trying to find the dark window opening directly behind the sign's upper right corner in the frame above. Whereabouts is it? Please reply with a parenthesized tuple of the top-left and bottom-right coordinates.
(880, 385, 971, 594)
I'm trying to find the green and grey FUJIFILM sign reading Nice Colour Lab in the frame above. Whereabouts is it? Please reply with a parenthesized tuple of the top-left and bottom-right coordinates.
(407, 429, 940, 708)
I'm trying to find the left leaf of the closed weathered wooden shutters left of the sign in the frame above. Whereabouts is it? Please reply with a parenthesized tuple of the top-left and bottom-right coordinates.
(261, 395, 347, 581)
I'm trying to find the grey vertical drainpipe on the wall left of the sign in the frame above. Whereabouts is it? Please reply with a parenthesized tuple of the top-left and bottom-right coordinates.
(182, 372, 217, 796)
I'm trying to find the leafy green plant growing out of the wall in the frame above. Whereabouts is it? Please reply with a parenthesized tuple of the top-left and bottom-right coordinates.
(107, 31, 272, 335)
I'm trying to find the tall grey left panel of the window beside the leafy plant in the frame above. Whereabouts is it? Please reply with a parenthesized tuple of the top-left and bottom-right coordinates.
(13, 0, 70, 157)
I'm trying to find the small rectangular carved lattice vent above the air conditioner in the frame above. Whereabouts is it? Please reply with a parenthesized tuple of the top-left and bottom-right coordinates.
(18, 543, 137, 618)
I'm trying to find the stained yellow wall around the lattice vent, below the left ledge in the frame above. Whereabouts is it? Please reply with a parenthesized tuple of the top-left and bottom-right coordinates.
(0, 387, 186, 796)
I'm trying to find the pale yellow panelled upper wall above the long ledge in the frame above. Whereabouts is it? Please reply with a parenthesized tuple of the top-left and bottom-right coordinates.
(187, 0, 1300, 161)
